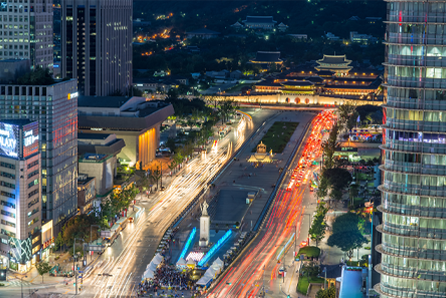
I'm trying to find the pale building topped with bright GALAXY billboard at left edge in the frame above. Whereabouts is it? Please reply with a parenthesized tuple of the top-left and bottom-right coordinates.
(0, 119, 41, 273)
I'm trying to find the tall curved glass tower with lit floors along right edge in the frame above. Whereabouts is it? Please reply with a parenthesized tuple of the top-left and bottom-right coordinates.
(374, 0, 446, 298)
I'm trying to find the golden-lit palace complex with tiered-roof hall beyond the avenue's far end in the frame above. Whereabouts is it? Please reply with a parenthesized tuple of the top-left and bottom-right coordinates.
(253, 55, 382, 100)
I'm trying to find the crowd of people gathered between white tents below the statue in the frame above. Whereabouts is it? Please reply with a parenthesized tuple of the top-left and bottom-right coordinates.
(137, 263, 198, 297)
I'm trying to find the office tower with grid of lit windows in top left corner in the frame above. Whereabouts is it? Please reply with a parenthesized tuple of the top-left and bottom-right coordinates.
(0, 0, 53, 70)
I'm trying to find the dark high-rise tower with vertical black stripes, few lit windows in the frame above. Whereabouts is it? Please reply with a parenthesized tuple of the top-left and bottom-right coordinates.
(61, 0, 133, 96)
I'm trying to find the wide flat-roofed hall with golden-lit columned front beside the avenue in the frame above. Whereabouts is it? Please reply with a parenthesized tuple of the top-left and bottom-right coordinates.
(79, 96, 174, 169)
